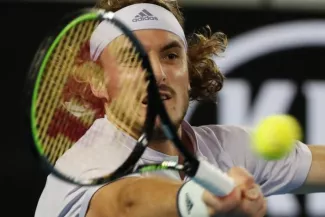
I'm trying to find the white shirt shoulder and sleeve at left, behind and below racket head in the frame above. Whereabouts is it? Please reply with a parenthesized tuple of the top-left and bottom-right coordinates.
(35, 119, 135, 217)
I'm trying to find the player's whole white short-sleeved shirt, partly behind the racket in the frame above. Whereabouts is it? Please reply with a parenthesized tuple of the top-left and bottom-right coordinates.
(35, 118, 312, 217)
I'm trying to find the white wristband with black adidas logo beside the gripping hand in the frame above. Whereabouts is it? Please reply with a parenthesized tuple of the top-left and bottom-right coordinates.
(177, 181, 209, 217)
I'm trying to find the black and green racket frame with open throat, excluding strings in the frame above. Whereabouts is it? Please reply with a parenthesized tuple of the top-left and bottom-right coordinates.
(25, 9, 200, 186)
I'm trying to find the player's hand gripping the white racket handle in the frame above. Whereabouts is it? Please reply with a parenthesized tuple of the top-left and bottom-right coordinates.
(203, 167, 266, 217)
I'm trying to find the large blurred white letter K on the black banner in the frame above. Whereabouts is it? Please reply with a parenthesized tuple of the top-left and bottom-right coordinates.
(218, 79, 297, 127)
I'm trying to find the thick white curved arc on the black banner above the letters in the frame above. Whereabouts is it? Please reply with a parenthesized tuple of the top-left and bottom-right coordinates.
(215, 20, 325, 75)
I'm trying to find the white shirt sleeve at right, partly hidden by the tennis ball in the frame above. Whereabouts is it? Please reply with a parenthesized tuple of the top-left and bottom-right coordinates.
(208, 126, 312, 196)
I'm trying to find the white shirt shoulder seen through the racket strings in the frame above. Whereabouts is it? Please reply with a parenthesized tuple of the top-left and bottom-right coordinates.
(55, 119, 131, 177)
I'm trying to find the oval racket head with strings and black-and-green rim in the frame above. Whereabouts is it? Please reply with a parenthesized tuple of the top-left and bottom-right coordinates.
(26, 9, 159, 185)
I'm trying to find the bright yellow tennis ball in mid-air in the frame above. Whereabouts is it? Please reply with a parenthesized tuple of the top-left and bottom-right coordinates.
(252, 115, 302, 160)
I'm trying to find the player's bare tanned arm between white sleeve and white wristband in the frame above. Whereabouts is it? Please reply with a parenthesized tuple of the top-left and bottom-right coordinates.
(87, 177, 182, 217)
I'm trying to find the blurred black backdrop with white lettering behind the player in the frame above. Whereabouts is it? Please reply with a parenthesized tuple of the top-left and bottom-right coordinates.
(0, 0, 325, 217)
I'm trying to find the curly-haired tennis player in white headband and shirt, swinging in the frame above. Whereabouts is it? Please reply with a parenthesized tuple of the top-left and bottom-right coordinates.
(35, 0, 325, 217)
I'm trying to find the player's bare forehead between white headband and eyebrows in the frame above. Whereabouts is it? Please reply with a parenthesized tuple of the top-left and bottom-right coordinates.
(133, 29, 185, 50)
